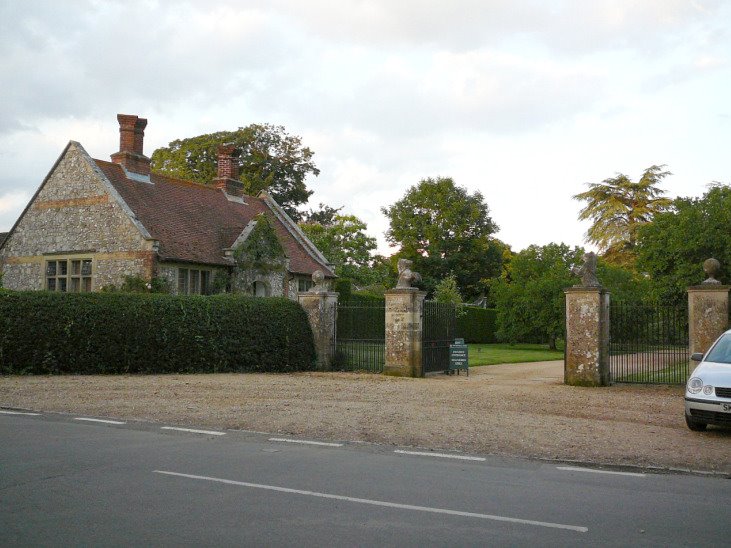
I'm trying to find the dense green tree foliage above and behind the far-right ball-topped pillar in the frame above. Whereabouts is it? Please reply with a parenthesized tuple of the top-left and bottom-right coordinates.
(637, 185, 731, 303)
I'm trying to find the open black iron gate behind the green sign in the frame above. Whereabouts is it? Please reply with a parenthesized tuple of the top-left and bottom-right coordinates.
(421, 301, 457, 375)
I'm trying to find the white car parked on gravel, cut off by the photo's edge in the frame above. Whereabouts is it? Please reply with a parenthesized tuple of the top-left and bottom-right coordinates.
(685, 329, 731, 431)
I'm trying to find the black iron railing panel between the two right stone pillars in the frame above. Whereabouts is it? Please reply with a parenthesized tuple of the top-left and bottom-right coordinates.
(609, 302, 690, 384)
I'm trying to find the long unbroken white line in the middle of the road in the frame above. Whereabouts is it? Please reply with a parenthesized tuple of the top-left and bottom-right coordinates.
(153, 470, 589, 533)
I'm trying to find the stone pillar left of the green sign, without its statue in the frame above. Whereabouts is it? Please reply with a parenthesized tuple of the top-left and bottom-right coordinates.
(383, 287, 426, 377)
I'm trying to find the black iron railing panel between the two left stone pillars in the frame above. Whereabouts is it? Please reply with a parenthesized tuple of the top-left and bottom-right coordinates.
(333, 300, 386, 373)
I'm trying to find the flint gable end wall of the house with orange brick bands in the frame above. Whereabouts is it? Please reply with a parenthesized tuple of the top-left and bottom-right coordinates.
(0, 143, 154, 290)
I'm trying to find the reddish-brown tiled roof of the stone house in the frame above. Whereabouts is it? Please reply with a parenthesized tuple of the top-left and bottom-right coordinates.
(94, 160, 333, 276)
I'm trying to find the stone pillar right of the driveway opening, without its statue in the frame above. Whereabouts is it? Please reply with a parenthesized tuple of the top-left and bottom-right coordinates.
(563, 287, 609, 386)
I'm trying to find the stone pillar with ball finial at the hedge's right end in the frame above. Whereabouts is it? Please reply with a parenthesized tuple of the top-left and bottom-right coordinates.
(297, 270, 338, 370)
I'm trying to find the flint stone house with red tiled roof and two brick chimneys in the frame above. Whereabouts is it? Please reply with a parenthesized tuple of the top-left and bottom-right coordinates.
(0, 114, 334, 299)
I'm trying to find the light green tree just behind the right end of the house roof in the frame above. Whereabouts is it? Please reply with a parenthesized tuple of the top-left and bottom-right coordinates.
(300, 213, 376, 286)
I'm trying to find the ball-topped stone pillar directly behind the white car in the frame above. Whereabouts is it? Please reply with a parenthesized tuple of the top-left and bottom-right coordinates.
(688, 259, 731, 354)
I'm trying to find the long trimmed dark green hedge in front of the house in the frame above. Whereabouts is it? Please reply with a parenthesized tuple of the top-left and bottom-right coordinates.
(0, 290, 316, 374)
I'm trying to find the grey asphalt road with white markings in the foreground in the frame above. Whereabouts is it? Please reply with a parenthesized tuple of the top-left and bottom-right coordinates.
(0, 410, 731, 546)
